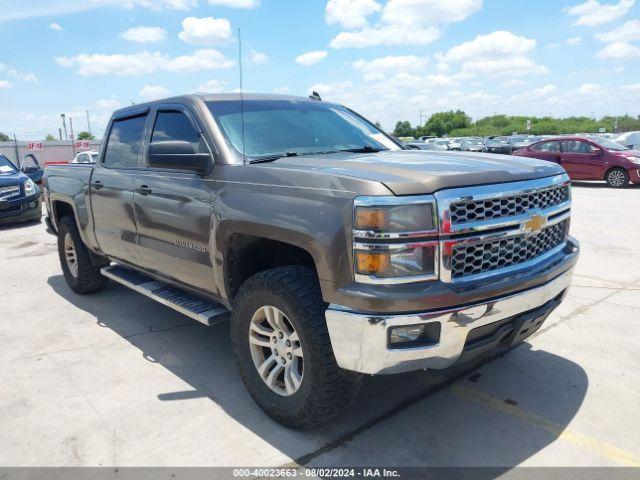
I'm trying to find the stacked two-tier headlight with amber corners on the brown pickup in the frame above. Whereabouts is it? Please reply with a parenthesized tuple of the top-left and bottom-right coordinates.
(353, 195, 438, 284)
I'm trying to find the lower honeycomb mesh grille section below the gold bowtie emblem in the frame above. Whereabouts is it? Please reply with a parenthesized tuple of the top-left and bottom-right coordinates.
(451, 220, 569, 279)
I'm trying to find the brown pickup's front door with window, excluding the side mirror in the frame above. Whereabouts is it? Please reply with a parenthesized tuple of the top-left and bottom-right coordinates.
(134, 105, 216, 293)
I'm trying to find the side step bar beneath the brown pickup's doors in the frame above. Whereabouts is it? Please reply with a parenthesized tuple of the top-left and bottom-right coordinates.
(100, 265, 230, 326)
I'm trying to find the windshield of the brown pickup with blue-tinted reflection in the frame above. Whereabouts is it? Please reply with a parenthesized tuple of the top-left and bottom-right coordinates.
(207, 100, 400, 159)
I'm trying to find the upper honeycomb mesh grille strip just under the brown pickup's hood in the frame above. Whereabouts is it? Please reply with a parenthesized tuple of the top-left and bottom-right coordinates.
(450, 185, 569, 225)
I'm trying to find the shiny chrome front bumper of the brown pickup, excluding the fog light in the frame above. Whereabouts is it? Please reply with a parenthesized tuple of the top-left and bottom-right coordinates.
(326, 270, 573, 374)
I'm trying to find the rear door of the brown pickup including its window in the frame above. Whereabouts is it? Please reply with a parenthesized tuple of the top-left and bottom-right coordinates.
(90, 112, 148, 264)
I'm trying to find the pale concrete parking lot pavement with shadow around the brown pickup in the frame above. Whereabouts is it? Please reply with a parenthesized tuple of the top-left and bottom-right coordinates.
(0, 184, 640, 469)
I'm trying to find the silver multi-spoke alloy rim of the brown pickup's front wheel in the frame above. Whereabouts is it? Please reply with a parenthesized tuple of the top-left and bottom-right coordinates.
(248, 306, 304, 397)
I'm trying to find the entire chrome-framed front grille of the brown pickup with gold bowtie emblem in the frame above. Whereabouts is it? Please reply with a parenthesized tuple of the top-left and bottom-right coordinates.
(435, 174, 571, 283)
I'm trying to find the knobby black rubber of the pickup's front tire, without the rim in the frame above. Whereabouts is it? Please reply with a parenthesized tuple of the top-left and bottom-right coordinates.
(231, 266, 362, 429)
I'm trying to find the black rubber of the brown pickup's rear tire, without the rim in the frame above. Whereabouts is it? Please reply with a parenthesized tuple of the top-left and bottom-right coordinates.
(58, 216, 108, 294)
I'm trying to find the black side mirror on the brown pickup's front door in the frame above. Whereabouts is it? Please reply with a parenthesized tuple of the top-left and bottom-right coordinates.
(147, 140, 211, 173)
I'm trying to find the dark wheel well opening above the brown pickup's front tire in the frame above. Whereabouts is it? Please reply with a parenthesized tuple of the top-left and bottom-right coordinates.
(225, 234, 316, 299)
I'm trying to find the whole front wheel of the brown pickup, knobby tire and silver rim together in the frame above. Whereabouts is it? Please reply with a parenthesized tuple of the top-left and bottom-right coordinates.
(231, 266, 362, 428)
